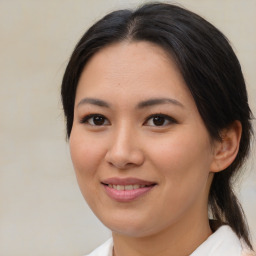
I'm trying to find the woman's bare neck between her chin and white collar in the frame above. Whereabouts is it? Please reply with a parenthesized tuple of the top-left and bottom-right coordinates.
(113, 207, 212, 256)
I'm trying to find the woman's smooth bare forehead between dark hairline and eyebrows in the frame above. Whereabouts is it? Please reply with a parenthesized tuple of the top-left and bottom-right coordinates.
(76, 41, 193, 108)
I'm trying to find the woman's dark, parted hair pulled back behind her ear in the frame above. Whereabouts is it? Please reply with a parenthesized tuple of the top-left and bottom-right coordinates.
(61, 3, 252, 249)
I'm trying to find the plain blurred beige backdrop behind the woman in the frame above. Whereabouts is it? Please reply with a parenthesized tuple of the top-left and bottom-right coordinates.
(0, 0, 256, 256)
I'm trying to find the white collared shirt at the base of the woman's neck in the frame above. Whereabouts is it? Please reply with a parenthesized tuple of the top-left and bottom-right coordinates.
(85, 225, 253, 256)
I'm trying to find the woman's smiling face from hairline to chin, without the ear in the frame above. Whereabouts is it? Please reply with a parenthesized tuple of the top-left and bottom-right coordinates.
(70, 42, 216, 237)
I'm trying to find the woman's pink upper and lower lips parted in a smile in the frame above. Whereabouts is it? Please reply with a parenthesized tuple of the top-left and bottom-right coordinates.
(101, 177, 156, 202)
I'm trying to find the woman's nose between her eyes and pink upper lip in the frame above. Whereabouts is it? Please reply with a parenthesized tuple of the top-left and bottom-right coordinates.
(105, 125, 145, 169)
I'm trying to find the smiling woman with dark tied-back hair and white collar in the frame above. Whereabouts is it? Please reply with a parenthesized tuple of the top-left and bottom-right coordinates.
(62, 3, 252, 256)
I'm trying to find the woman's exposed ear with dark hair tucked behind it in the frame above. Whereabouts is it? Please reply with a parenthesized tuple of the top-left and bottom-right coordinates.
(211, 121, 242, 172)
